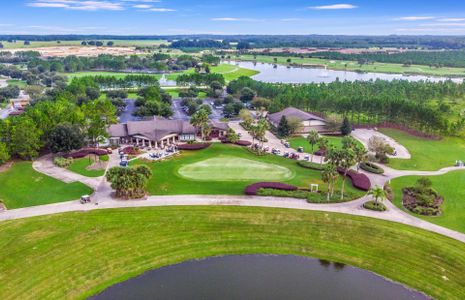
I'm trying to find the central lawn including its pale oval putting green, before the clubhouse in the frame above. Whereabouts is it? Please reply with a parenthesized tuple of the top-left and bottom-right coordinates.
(134, 144, 364, 197)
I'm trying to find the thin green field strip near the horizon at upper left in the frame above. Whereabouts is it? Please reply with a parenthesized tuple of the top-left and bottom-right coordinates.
(3, 40, 167, 49)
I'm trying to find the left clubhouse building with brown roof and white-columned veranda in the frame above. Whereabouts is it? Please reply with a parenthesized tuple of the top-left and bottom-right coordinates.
(108, 117, 229, 149)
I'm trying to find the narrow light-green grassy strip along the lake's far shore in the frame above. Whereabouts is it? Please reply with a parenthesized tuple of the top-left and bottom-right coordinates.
(237, 55, 465, 77)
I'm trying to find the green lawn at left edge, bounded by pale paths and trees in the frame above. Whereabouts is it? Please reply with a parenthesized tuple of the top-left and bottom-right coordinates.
(0, 162, 92, 209)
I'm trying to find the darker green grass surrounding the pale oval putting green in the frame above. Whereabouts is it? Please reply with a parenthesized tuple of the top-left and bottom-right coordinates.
(134, 144, 364, 197)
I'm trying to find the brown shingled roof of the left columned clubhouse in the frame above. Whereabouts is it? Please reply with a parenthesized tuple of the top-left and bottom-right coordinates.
(108, 117, 196, 141)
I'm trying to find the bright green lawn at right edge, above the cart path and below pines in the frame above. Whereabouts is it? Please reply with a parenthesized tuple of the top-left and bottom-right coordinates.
(379, 128, 465, 171)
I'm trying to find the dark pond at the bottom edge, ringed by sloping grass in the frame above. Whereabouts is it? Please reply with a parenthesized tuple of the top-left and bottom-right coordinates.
(91, 255, 428, 300)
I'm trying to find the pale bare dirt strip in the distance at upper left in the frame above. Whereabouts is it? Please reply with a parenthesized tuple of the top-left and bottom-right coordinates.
(1, 46, 142, 57)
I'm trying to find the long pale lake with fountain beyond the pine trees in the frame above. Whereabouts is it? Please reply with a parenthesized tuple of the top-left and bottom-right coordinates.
(227, 62, 463, 83)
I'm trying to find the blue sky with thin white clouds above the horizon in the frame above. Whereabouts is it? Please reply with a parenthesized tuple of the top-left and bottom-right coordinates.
(0, 0, 465, 35)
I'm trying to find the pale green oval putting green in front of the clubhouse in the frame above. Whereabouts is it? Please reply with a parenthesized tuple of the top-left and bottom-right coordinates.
(178, 155, 294, 181)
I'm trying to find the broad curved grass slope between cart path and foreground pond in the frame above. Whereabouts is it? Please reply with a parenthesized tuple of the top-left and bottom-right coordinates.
(0, 206, 465, 300)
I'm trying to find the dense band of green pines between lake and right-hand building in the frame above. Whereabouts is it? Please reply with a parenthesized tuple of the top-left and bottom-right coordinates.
(227, 77, 465, 134)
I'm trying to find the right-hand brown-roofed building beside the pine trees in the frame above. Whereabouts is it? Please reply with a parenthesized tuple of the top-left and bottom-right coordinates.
(268, 107, 326, 133)
